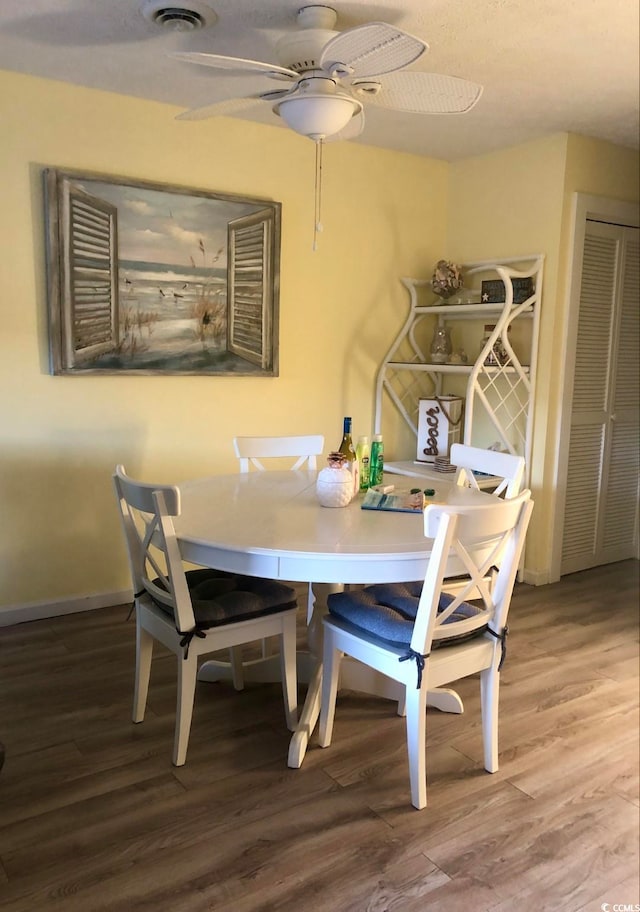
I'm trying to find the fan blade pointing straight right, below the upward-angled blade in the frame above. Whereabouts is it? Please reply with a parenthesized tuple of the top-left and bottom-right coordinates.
(352, 71, 482, 114)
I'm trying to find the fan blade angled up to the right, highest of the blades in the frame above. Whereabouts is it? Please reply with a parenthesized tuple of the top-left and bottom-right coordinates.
(320, 22, 428, 78)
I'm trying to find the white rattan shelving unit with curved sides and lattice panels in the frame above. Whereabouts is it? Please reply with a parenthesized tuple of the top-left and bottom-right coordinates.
(374, 254, 544, 488)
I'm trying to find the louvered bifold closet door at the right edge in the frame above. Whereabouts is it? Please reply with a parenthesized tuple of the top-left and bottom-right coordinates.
(561, 221, 640, 574)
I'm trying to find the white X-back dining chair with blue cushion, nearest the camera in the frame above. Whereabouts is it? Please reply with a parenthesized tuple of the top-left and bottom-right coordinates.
(320, 490, 533, 809)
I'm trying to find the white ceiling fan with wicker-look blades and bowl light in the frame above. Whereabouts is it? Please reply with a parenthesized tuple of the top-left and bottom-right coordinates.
(171, 5, 482, 143)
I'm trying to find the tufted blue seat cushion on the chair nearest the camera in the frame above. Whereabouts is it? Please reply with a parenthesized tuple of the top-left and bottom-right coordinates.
(327, 582, 488, 648)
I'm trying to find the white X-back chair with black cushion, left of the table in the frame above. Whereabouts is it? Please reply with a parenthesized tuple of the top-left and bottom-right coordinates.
(113, 465, 297, 766)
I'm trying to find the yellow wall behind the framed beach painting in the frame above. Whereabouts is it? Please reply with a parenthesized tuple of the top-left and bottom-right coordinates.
(0, 72, 448, 606)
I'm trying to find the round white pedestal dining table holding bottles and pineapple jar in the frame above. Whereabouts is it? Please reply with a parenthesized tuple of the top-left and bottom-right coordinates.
(175, 470, 490, 767)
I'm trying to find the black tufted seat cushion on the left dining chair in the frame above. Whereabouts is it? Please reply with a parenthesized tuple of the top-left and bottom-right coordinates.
(154, 570, 296, 630)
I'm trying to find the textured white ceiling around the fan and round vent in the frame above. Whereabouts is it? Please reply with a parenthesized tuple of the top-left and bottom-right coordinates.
(0, 0, 640, 161)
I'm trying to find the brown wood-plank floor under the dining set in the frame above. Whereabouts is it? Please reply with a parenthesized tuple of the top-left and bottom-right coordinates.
(0, 561, 640, 912)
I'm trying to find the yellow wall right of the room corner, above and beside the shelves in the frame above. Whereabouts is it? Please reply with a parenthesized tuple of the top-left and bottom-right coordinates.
(447, 133, 639, 582)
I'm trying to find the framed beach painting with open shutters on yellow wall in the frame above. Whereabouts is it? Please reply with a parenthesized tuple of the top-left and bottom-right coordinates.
(44, 168, 281, 377)
